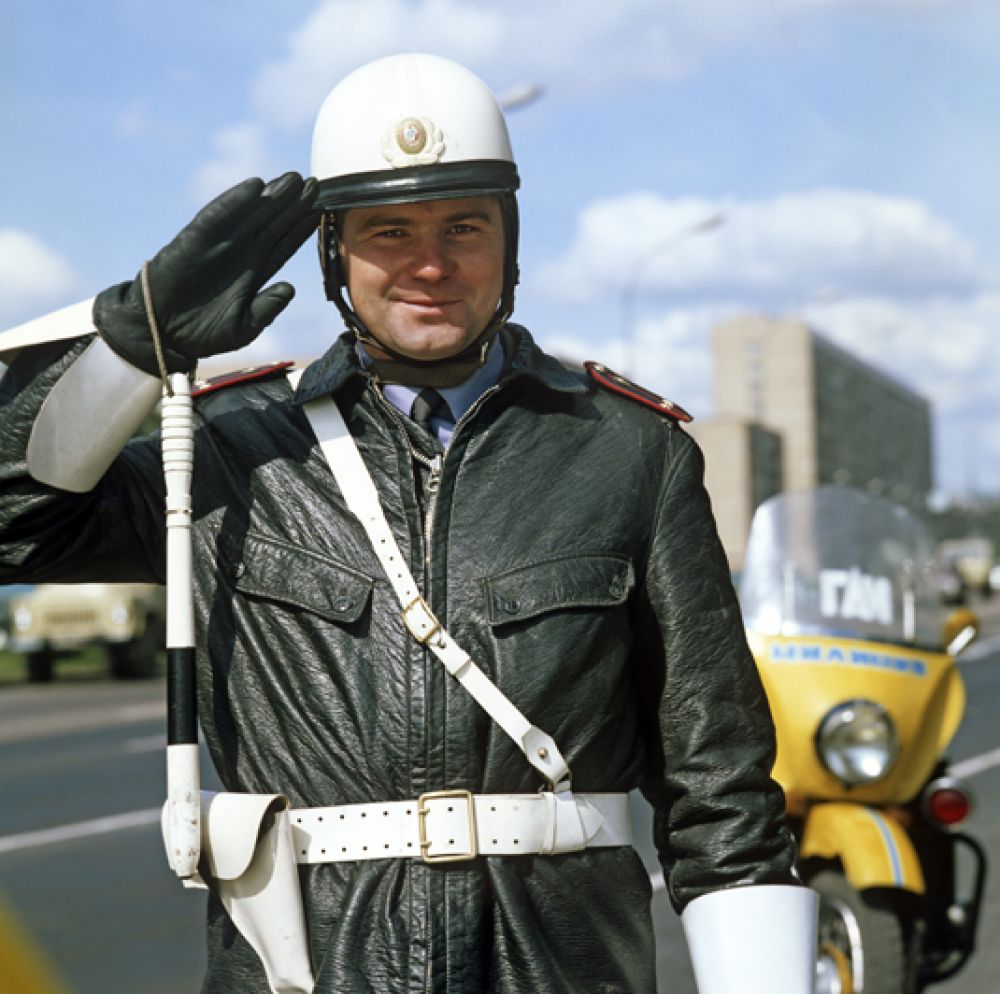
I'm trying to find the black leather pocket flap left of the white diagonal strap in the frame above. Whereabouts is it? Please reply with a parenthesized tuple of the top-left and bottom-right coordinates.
(230, 534, 374, 624)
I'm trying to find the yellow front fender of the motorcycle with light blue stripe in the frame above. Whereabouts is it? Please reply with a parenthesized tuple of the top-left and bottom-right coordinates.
(799, 801, 924, 894)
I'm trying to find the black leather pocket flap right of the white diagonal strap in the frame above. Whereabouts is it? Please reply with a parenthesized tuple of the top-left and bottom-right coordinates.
(483, 553, 635, 625)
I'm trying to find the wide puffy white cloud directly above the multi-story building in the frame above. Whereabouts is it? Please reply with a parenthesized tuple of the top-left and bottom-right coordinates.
(539, 190, 995, 306)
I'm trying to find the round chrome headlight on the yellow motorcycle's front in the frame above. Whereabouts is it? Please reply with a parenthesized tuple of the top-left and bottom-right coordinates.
(816, 698, 899, 786)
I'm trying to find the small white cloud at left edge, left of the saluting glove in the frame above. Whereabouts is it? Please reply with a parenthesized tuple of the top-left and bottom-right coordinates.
(0, 228, 82, 328)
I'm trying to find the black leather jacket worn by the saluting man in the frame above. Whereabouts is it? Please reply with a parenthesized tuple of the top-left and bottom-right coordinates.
(0, 326, 793, 994)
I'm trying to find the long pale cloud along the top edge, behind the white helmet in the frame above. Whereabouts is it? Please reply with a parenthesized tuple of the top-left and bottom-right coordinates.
(248, 0, 984, 127)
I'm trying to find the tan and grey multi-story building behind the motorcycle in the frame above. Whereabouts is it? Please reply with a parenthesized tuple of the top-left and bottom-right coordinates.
(692, 316, 932, 570)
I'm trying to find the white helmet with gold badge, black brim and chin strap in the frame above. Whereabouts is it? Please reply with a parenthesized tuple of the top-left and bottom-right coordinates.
(312, 53, 520, 365)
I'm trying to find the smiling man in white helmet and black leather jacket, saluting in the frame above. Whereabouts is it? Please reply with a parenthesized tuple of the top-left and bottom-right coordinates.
(0, 55, 814, 994)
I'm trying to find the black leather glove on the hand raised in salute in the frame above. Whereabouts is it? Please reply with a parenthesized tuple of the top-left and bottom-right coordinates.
(94, 173, 319, 376)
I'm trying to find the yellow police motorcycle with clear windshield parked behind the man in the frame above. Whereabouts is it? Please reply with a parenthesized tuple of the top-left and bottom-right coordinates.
(740, 487, 986, 994)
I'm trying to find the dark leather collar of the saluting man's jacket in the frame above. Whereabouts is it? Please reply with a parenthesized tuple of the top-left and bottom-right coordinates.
(294, 324, 587, 404)
